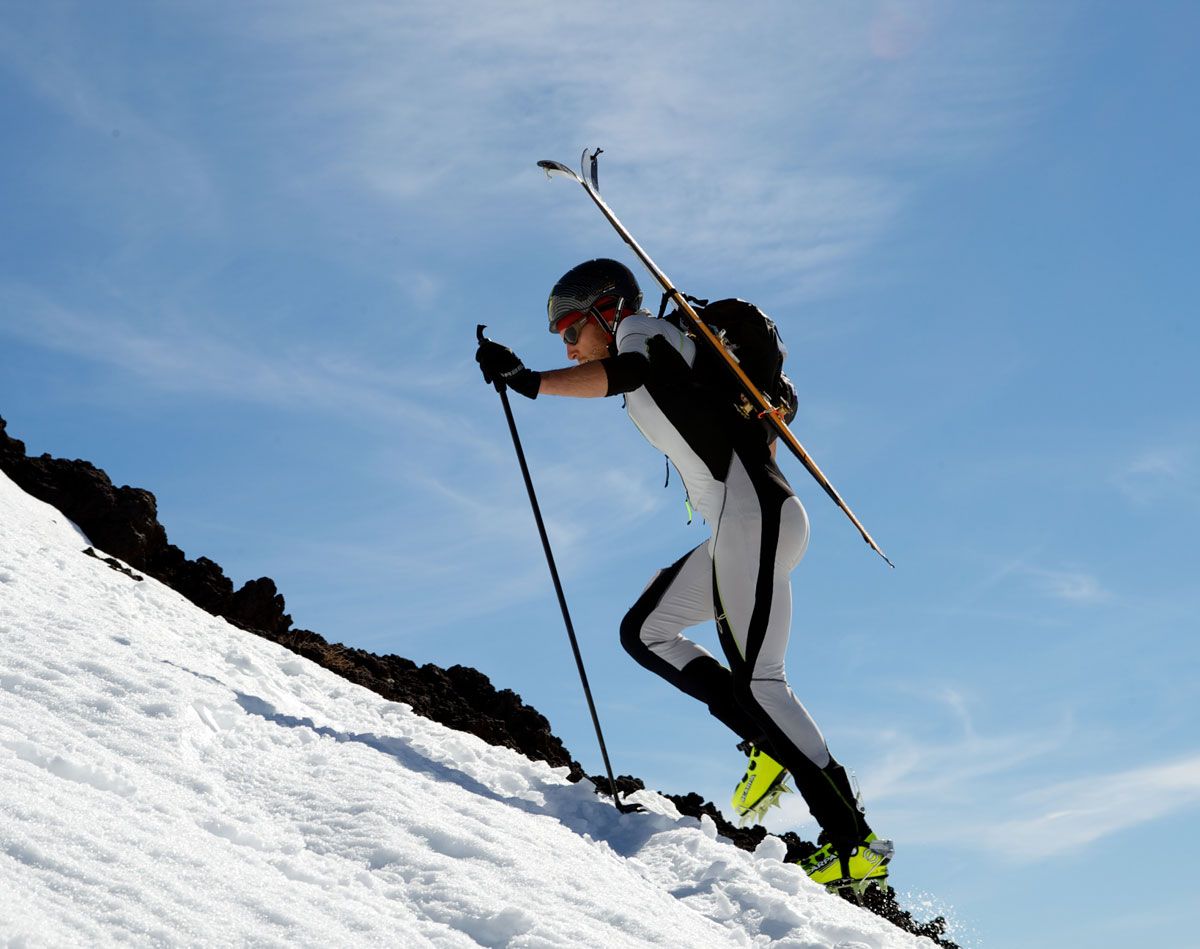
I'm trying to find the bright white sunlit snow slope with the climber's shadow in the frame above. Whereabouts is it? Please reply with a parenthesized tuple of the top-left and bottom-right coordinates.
(0, 474, 934, 949)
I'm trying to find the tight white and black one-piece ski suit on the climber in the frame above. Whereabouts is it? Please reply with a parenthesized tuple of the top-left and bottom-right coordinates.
(604, 314, 870, 843)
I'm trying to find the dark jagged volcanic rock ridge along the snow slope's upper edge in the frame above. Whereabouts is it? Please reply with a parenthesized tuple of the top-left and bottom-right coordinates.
(0, 419, 958, 949)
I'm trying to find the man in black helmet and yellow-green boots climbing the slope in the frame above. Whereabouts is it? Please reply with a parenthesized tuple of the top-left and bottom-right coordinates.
(476, 258, 893, 893)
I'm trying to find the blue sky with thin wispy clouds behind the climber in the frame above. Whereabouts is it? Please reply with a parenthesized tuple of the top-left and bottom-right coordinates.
(0, 0, 1200, 947)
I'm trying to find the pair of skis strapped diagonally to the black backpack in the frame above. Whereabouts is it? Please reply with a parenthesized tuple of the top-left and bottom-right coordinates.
(538, 149, 895, 567)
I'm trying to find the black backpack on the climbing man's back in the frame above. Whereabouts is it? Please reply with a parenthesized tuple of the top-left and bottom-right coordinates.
(659, 294, 797, 438)
